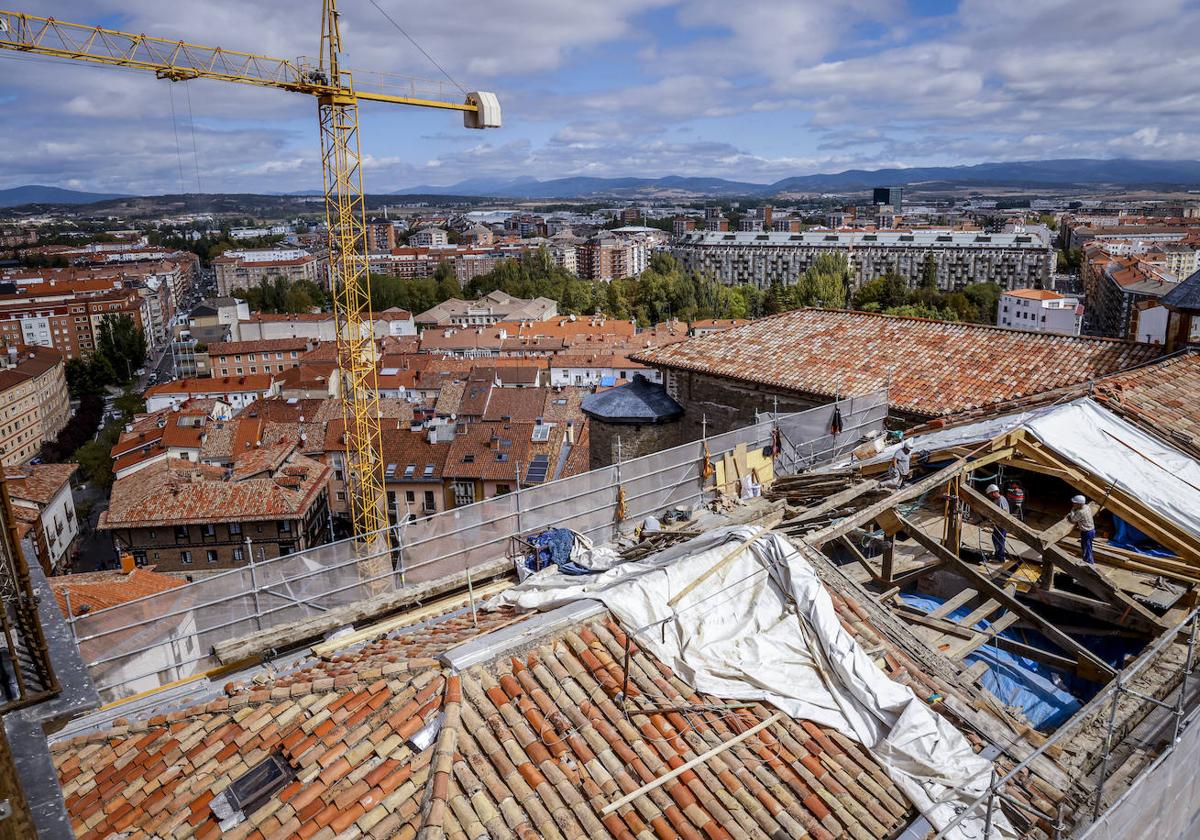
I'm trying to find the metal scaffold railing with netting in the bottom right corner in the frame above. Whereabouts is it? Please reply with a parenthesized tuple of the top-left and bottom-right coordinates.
(934, 607, 1200, 840)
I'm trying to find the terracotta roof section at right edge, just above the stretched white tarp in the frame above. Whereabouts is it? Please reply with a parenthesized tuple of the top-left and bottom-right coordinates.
(1092, 350, 1200, 457)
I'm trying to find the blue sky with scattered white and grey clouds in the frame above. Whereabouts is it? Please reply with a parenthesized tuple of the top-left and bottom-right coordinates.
(0, 0, 1200, 194)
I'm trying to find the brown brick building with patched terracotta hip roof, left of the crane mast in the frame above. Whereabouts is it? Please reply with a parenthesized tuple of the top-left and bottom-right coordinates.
(100, 442, 330, 572)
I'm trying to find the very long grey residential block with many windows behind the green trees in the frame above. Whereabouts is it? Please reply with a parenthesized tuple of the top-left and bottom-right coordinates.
(672, 230, 1054, 290)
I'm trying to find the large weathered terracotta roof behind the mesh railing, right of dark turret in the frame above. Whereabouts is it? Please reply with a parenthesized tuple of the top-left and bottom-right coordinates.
(634, 310, 1162, 418)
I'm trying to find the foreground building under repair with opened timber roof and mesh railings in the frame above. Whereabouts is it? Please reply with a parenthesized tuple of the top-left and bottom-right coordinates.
(21, 362, 1200, 840)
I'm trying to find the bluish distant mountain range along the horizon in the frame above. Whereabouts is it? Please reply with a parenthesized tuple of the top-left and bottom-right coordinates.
(7, 158, 1200, 208)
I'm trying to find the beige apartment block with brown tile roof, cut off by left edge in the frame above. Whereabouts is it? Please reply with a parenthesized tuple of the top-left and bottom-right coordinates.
(0, 344, 71, 467)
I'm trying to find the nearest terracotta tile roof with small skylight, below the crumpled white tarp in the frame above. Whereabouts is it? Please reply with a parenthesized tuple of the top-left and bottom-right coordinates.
(52, 604, 926, 840)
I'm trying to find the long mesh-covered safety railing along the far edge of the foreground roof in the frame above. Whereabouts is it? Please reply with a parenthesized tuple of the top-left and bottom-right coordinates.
(68, 392, 887, 701)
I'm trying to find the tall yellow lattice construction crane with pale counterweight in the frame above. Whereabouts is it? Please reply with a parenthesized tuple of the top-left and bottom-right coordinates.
(0, 8, 500, 568)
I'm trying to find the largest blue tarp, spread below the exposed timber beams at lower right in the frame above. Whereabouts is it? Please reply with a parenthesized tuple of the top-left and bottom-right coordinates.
(900, 593, 1080, 730)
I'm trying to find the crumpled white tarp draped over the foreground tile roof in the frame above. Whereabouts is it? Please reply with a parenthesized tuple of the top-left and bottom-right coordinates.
(491, 526, 1016, 839)
